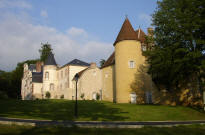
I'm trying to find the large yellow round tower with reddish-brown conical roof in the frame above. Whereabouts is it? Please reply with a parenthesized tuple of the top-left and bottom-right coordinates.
(114, 18, 144, 103)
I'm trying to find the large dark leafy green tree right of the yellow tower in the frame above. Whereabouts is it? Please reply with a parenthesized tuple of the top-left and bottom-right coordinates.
(145, 0, 205, 91)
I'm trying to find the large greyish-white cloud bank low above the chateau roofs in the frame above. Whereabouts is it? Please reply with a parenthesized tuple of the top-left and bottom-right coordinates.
(0, 15, 113, 71)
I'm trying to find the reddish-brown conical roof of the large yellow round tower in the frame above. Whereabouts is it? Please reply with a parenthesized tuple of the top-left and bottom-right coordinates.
(114, 18, 137, 45)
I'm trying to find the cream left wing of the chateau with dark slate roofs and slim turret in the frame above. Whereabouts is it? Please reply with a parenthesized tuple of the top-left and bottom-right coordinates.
(21, 53, 98, 100)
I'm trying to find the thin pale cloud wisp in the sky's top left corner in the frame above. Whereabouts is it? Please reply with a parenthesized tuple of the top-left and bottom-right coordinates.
(0, 0, 32, 9)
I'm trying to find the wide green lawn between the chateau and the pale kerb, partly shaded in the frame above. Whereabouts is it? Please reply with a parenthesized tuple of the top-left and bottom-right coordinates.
(0, 100, 205, 121)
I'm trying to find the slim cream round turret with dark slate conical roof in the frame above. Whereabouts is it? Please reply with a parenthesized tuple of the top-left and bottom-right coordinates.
(42, 53, 57, 98)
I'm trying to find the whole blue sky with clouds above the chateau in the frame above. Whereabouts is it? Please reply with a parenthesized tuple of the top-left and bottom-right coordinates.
(0, 0, 157, 71)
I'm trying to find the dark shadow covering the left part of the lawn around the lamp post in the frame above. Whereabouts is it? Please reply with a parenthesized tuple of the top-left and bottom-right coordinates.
(0, 100, 127, 121)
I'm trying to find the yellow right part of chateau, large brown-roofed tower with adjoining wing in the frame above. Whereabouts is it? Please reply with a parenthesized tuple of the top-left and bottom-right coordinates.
(101, 18, 154, 103)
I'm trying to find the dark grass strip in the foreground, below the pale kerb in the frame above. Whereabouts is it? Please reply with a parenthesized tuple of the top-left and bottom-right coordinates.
(0, 125, 205, 135)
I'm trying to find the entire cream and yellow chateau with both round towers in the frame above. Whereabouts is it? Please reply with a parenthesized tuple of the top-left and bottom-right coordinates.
(21, 18, 154, 103)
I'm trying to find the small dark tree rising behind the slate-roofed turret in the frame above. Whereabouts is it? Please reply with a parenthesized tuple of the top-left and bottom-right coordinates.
(39, 42, 53, 62)
